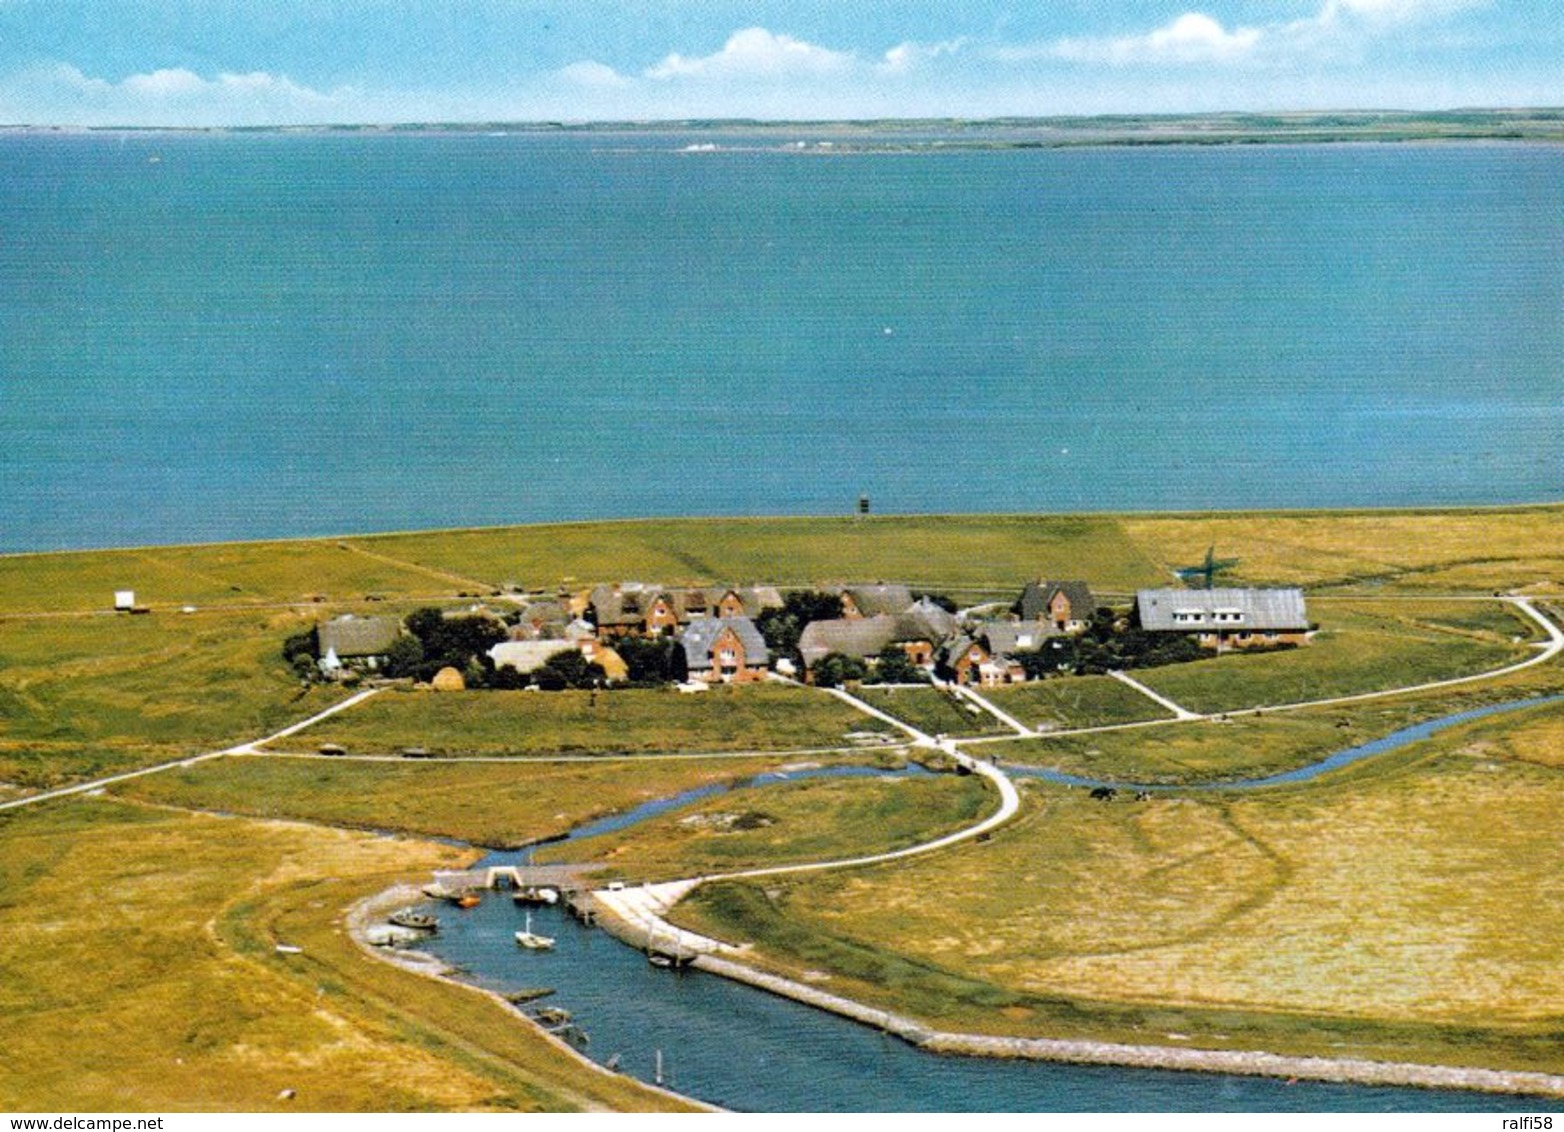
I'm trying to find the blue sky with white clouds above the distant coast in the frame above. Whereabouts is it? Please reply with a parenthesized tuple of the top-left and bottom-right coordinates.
(0, 0, 1564, 127)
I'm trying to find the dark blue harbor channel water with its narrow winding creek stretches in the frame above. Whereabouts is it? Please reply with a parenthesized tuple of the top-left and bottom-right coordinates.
(403, 697, 1564, 1113)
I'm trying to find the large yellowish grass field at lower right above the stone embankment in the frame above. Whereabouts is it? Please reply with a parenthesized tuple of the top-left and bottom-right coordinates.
(680, 694, 1564, 1073)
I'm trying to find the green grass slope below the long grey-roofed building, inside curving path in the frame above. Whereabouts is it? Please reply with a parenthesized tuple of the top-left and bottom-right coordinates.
(1134, 602, 1531, 713)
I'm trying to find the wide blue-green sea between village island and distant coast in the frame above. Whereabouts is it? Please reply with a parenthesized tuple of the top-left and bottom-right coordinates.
(0, 128, 1564, 550)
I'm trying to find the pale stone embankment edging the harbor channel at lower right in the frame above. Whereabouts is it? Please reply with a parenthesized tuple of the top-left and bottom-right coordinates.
(691, 955, 1564, 1098)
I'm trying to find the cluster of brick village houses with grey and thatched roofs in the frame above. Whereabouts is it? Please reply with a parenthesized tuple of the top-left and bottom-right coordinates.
(314, 580, 1311, 691)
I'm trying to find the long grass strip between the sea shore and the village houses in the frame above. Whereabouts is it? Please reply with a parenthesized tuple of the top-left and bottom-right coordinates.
(0, 507, 1564, 614)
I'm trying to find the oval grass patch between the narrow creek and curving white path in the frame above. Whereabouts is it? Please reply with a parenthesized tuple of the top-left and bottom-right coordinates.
(535, 774, 998, 880)
